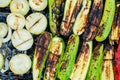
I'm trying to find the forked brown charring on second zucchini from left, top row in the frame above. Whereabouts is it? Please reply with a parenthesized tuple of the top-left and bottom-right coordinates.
(60, 0, 81, 36)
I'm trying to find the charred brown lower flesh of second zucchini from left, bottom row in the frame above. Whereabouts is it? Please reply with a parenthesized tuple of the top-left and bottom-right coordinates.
(46, 53, 60, 77)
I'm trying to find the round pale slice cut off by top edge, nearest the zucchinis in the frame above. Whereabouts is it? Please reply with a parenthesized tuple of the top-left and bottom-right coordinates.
(29, 0, 47, 11)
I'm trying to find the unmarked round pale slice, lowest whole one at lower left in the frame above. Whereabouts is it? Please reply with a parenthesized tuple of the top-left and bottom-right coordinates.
(9, 53, 31, 74)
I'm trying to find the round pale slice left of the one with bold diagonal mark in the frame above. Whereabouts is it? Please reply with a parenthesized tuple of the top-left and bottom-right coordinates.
(7, 13, 25, 30)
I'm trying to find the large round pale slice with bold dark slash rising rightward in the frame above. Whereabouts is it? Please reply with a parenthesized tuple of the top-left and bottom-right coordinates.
(26, 12, 47, 35)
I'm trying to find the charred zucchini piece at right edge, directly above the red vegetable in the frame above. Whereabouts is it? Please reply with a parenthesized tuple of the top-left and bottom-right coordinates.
(110, 4, 120, 44)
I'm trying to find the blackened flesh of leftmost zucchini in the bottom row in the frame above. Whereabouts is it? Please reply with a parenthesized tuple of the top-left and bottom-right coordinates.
(36, 32, 51, 69)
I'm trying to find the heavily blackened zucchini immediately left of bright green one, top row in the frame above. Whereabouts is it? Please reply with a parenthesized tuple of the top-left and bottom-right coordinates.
(83, 0, 103, 41)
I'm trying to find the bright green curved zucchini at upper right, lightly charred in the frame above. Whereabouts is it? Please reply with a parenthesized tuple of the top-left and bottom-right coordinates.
(95, 0, 115, 42)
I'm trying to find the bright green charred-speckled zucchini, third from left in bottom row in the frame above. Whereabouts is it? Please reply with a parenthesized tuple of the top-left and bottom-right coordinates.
(57, 34, 79, 80)
